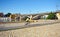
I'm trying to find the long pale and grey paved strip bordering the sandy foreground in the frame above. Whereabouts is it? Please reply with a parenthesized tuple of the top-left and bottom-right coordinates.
(0, 20, 60, 31)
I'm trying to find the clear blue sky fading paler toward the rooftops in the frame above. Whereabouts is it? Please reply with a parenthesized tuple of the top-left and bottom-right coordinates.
(0, 0, 60, 14)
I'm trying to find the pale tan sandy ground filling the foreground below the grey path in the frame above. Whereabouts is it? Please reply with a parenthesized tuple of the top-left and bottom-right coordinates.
(0, 23, 60, 37)
